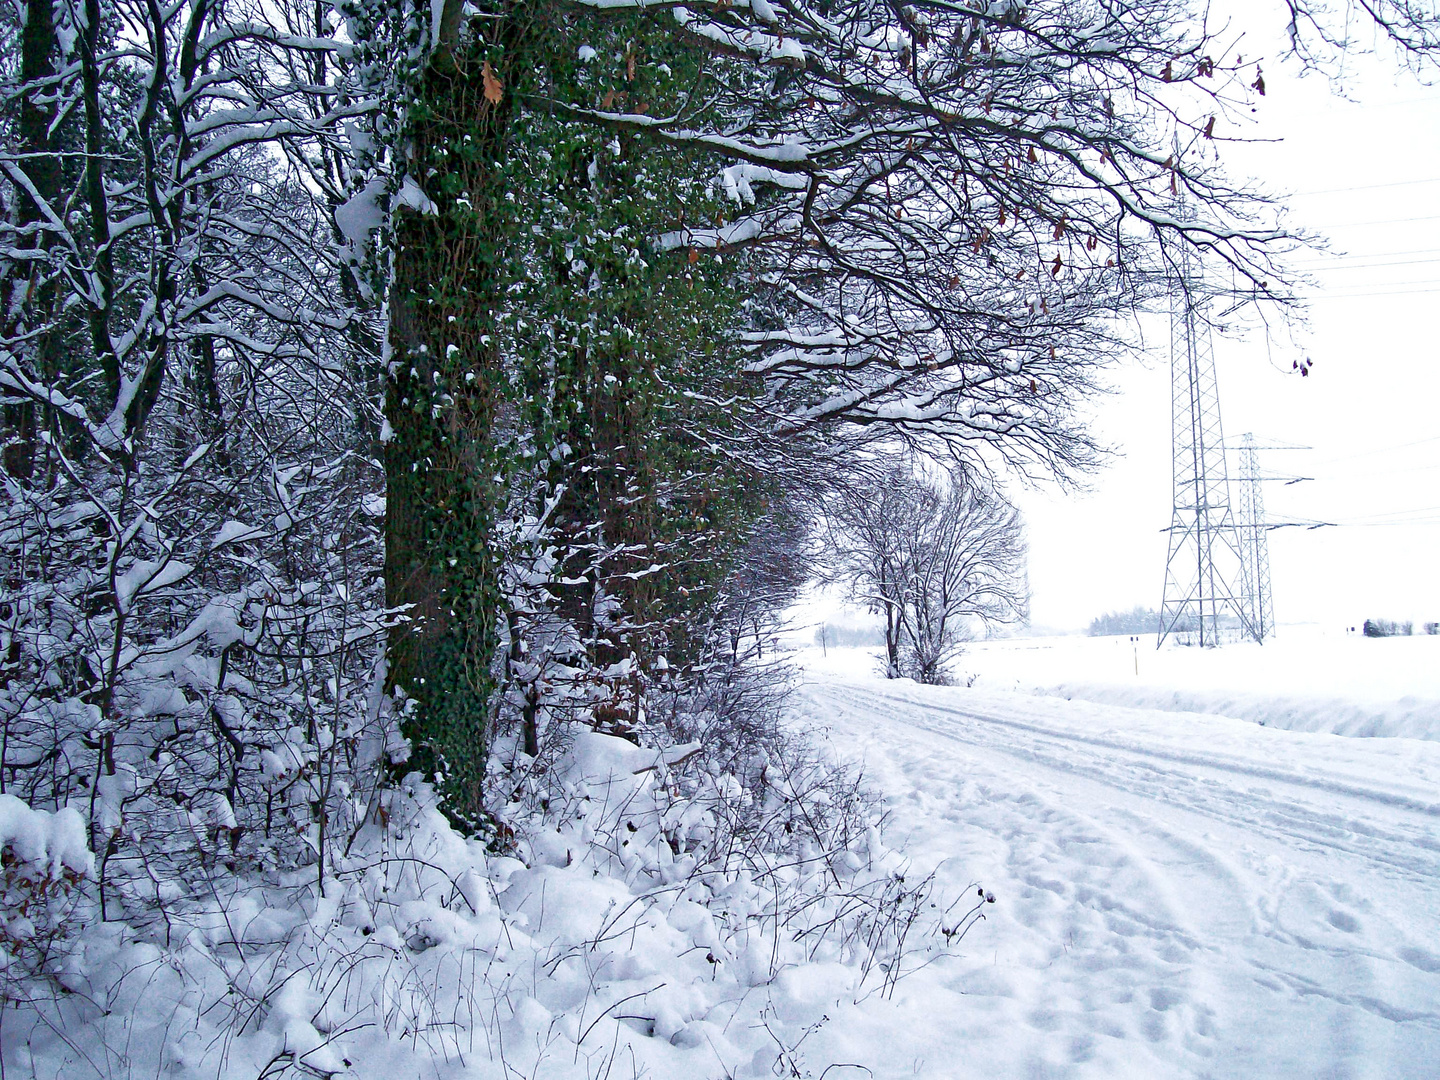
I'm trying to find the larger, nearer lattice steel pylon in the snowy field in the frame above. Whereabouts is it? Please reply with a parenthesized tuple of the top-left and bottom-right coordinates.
(1155, 248, 1260, 648)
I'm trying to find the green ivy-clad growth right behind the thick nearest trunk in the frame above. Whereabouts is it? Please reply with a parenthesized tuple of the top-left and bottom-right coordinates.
(501, 19, 765, 737)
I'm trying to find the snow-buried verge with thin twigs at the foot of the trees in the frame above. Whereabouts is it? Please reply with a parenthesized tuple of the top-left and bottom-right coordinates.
(6, 711, 985, 1080)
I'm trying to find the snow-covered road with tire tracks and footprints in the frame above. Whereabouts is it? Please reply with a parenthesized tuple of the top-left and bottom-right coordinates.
(798, 675, 1440, 1079)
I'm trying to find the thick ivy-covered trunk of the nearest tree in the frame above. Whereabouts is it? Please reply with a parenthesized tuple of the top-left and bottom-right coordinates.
(384, 12, 524, 828)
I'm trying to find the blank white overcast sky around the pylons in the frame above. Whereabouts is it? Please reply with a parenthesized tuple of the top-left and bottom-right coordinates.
(1012, 14, 1440, 632)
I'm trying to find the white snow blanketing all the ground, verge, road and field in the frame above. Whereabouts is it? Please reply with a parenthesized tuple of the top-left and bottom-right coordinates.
(11, 634, 1440, 1080)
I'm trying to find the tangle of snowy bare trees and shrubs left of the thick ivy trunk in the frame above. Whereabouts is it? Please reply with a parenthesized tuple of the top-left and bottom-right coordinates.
(0, 0, 397, 939)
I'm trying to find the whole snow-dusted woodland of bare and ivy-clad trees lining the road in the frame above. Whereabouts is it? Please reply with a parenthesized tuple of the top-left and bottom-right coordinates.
(0, 0, 1437, 1074)
